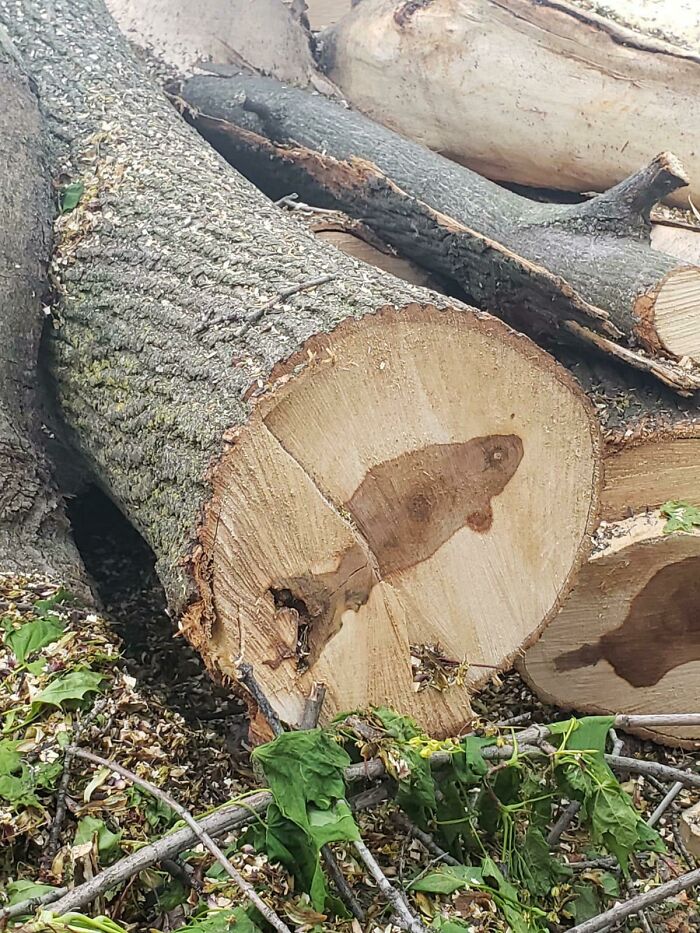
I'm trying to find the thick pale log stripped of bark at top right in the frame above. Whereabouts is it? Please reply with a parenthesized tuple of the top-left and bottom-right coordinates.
(320, 0, 700, 207)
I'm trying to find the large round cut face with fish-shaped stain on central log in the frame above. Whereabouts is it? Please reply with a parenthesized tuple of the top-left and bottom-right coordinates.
(185, 306, 598, 735)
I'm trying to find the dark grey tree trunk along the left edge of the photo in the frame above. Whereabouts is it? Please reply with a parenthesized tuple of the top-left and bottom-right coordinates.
(0, 29, 88, 596)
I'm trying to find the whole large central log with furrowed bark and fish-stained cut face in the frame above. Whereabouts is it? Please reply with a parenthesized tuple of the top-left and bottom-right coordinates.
(0, 0, 599, 734)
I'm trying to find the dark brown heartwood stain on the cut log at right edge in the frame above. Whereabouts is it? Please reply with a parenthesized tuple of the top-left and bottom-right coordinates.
(554, 557, 700, 687)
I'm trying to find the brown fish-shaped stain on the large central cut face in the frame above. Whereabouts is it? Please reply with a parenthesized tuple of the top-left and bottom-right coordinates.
(346, 434, 523, 577)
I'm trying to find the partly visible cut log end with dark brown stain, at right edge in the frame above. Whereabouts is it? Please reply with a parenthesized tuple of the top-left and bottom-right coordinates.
(521, 512, 700, 747)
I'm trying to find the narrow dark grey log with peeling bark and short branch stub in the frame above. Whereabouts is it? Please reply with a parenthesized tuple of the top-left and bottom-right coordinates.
(179, 75, 700, 393)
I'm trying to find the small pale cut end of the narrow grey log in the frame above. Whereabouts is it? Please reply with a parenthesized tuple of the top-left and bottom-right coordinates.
(654, 267, 700, 363)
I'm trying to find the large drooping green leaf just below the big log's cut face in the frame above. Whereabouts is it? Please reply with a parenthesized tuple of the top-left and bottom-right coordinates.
(253, 729, 359, 910)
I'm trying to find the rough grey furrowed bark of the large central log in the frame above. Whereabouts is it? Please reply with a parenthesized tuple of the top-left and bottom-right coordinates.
(0, 0, 492, 613)
